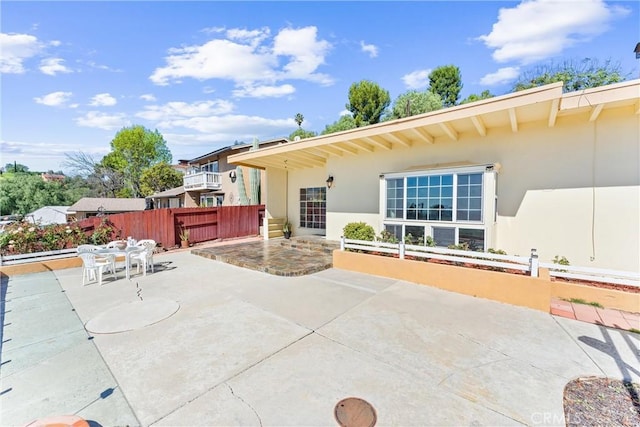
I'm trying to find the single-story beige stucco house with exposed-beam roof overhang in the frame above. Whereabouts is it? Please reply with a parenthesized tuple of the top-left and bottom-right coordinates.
(229, 80, 640, 271)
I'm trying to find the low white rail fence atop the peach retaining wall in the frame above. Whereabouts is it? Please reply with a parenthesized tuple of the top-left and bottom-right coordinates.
(340, 237, 640, 287)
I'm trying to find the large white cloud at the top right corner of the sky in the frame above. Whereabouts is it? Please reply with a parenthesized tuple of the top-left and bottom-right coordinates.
(478, 0, 629, 64)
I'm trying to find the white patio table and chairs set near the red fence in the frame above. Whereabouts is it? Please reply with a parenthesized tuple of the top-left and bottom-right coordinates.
(78, 238, 156, 286)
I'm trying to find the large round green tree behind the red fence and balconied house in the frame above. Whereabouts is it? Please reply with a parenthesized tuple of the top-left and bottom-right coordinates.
(100, 125, 172, 197)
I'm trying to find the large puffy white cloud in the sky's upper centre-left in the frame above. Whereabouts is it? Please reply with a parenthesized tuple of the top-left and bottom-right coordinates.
(149, 27, 332, 88)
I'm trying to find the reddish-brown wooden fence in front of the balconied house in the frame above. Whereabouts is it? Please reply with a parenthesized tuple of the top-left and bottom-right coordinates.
(78, 205, 265, 248)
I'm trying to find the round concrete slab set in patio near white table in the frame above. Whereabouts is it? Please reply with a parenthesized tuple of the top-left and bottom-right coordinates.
(85, 298, 180, 334)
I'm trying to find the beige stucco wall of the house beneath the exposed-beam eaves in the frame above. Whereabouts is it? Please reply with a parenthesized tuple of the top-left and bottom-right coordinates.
(267, 106, 640, 271)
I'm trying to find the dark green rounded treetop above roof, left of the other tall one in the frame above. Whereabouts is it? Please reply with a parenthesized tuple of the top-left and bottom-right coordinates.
(346, 80, 391, 127)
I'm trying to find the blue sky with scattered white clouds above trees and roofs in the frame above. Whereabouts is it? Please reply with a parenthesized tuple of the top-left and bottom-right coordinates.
(0, 0, 640, 171)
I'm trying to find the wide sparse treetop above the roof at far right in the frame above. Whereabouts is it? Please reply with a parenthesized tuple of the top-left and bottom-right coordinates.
(513, 58, 625, 92)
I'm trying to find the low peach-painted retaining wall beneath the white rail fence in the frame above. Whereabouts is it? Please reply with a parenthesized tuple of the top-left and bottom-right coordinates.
(333, 250, 640, 313)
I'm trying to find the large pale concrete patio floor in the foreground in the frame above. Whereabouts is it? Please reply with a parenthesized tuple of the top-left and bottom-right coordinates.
(0, 247, 640, 426)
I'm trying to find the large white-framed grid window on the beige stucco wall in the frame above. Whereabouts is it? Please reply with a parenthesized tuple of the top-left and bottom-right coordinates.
(383, 166, 495, 250)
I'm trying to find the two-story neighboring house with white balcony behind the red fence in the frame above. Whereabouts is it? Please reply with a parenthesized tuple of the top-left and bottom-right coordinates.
(149, 138, 289, 209)
